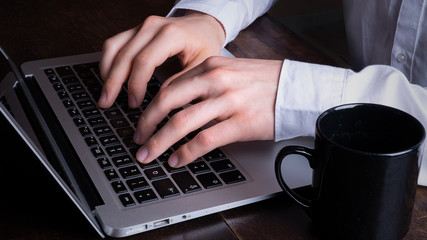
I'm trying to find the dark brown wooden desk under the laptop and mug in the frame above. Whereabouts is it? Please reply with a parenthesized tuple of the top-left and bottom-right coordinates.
(0, 0, 427, 239)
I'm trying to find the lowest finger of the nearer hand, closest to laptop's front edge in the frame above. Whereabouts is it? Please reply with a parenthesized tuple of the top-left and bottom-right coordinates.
(168, 117, 242, 167)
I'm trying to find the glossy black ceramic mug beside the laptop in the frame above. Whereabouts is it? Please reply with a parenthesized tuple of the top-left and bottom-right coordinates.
(275, 103, 426, 240)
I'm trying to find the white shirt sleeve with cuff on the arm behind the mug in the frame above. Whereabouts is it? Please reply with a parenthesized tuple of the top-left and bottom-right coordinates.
(275, 60, 427, 186)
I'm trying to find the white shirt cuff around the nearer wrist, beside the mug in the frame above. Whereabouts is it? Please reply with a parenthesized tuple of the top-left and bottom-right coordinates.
(275, 60, 347, 141)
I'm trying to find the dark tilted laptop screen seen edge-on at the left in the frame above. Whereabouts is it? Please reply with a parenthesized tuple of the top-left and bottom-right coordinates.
(0, 46, 103, 236)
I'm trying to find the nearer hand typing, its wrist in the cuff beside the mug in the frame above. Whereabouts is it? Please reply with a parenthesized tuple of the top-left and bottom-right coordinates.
(134, 57, 282, 167)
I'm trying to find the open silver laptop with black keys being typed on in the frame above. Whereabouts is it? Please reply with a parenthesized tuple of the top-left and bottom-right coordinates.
(0, 45, 313, 237)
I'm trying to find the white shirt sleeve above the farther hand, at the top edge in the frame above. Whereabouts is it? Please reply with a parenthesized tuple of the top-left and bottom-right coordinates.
(167, 0, 275, 46)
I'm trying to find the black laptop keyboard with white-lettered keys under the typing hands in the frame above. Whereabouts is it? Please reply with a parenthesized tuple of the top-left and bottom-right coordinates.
(44, 62, 246, 207)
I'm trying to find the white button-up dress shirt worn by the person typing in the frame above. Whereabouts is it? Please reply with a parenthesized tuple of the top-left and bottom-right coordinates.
(170, 0, 427, 186)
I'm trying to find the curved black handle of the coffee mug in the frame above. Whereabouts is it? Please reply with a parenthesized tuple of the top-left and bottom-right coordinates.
(275, 146, 315, 209)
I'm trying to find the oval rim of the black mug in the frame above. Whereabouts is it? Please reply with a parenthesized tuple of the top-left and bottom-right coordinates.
(316, 103, 426, 157)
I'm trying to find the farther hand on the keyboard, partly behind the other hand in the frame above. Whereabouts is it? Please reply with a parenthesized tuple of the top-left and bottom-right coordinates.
(98, 11, 225, 108)
